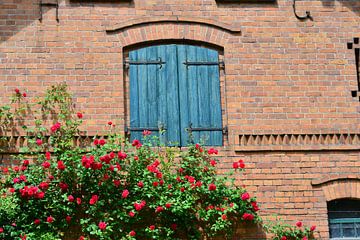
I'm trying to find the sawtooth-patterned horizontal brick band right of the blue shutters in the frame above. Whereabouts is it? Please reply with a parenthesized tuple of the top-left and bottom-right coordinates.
(234, 133, 360, 152)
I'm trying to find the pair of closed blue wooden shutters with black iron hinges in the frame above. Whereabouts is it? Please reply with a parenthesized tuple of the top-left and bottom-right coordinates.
(128, 44, 223, 146)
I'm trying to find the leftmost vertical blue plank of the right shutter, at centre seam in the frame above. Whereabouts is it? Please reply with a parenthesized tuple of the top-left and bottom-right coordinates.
(177, 45, 190, 146)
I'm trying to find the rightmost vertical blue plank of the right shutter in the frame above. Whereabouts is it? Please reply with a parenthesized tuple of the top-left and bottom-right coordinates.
(207, 49, 223, 146)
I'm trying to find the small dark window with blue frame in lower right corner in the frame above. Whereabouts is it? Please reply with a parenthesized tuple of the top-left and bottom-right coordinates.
(327, 199, 360, 240)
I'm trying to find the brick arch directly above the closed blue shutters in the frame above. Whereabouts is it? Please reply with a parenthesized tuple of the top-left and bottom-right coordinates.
(107, 21, 232, 47)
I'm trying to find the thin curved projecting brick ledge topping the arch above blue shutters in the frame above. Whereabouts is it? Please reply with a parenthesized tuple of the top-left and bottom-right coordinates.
(105, 16, 241, 34)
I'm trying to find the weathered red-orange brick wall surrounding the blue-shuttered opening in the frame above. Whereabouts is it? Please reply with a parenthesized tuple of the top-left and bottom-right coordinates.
(0, 0, 360, 239)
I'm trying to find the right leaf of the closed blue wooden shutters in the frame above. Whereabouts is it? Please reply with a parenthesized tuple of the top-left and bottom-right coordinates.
(178, 45, 222, 146)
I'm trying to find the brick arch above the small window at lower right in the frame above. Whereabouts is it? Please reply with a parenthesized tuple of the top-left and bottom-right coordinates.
(321, 179, 360, 202)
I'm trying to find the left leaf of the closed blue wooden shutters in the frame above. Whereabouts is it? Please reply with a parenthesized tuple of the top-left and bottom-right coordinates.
(129, 45, 180, 143)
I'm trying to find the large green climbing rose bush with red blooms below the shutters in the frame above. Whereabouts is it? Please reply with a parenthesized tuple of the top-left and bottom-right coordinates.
(0, 85, 260, 240)
